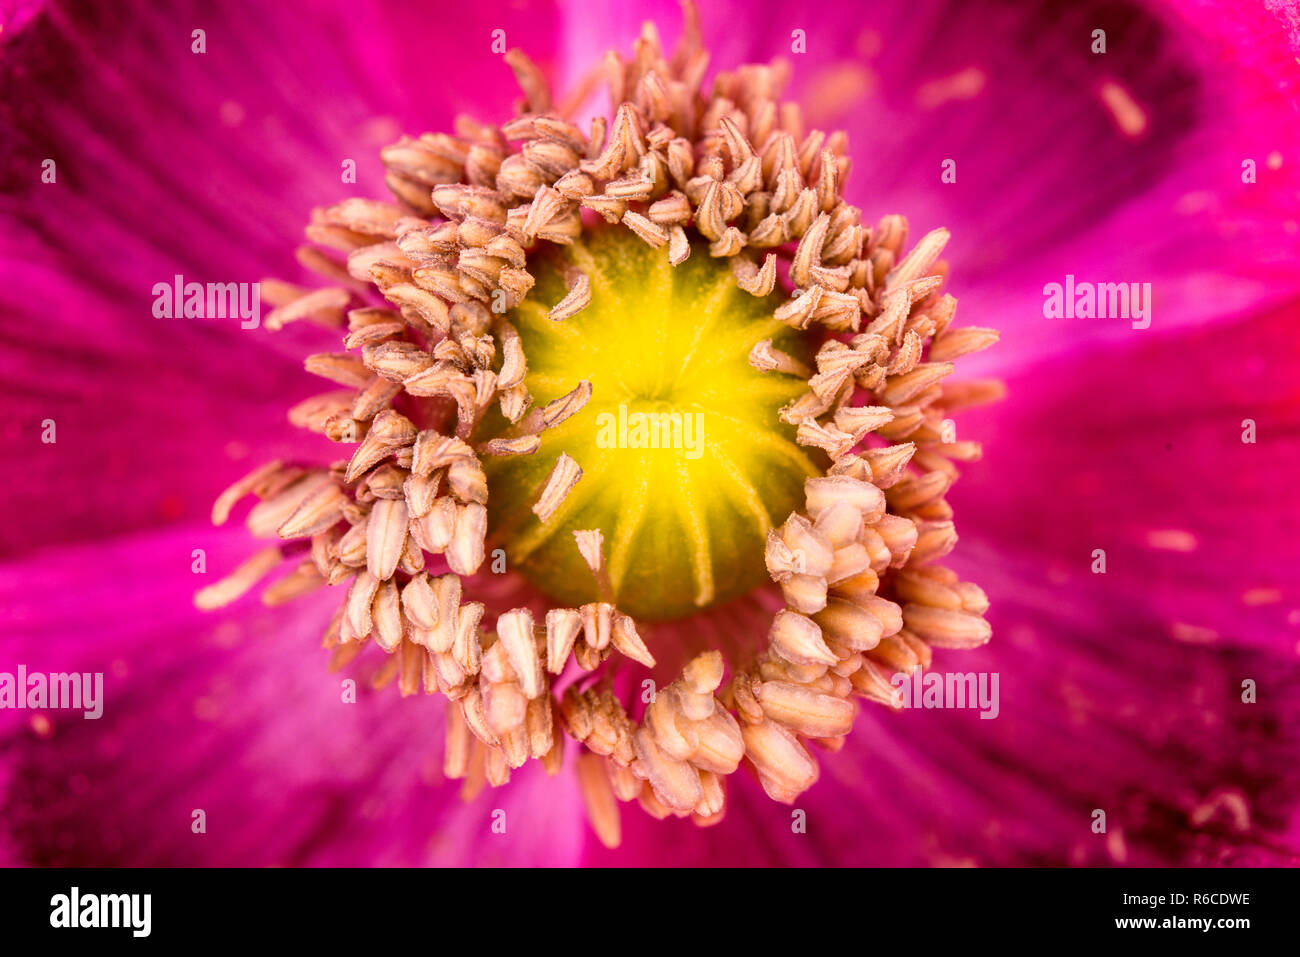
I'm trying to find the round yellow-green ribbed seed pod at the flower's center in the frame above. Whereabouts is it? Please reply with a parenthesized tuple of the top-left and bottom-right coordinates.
(485, 229, 820, 619)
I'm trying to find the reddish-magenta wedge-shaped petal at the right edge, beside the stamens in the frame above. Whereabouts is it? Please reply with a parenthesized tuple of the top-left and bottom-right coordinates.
(953, 306, 1300, 653)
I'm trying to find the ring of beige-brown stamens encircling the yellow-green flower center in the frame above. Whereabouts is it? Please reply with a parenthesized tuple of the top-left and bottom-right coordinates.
(196, 4, 1000, 845)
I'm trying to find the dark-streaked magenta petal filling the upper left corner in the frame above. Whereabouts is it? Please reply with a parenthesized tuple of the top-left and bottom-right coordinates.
(0, 3, 569, 554)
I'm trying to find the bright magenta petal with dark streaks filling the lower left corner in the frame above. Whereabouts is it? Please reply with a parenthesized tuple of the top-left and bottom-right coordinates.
(0, 528, 585, 866)
